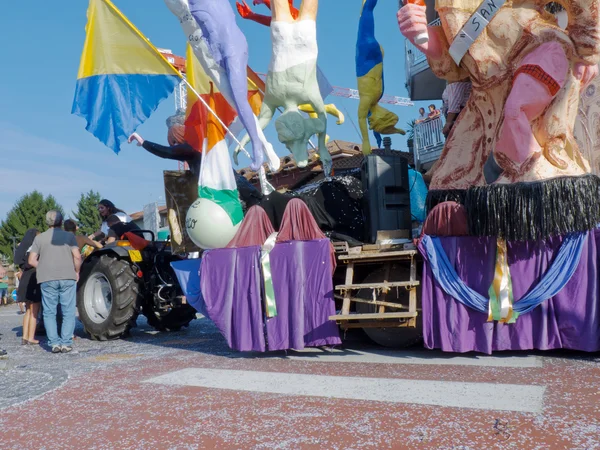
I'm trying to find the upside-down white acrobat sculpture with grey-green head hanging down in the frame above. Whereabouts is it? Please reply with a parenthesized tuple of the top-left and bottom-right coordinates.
(236, 0, 331, 173)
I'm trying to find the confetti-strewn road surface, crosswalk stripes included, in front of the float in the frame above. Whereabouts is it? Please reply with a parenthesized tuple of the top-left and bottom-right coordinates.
(0, 306, 600, 449)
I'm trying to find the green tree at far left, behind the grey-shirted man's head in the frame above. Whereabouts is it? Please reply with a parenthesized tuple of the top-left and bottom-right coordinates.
(0, 191, 64, 262)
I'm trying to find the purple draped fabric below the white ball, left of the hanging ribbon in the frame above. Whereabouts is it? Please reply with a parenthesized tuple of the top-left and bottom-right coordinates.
(200, 247, 265, 352)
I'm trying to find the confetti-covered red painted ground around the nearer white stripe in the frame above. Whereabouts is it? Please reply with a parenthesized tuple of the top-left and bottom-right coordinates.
(0, 342, 600, 449)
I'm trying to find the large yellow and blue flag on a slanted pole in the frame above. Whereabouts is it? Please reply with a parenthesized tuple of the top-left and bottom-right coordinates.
(71, 0, 181, 153)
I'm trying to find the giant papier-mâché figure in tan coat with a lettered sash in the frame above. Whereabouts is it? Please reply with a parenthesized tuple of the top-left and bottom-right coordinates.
(398, 0, 600, 238)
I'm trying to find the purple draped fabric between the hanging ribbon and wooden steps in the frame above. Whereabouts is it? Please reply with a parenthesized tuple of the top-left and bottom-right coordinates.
(267, 239, 342, 350)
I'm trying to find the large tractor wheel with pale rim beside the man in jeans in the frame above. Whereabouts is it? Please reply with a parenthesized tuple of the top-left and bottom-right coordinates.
(77, 254, 141, 341)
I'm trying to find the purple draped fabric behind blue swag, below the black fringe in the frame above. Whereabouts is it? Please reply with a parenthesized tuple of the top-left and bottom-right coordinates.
(422, 230, 600, 354)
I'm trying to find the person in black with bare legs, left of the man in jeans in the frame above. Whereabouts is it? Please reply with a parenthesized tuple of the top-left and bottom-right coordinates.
(14, 228, 42, 345)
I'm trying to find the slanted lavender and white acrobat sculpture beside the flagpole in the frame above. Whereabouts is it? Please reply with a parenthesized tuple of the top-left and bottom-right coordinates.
(165, 0, 281, 171)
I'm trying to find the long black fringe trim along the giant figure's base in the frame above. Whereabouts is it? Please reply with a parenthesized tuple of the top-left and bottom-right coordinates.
(427, 175, 600, 241)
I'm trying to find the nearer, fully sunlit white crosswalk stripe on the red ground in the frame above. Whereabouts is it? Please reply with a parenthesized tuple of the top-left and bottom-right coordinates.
(145, 368, 546, 414)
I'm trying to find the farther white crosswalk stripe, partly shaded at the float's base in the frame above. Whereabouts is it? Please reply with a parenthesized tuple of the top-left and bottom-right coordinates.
(264, 349, 543, 369)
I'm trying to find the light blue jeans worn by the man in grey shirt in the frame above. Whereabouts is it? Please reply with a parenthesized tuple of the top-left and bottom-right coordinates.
(40, 280, 77, 347)
